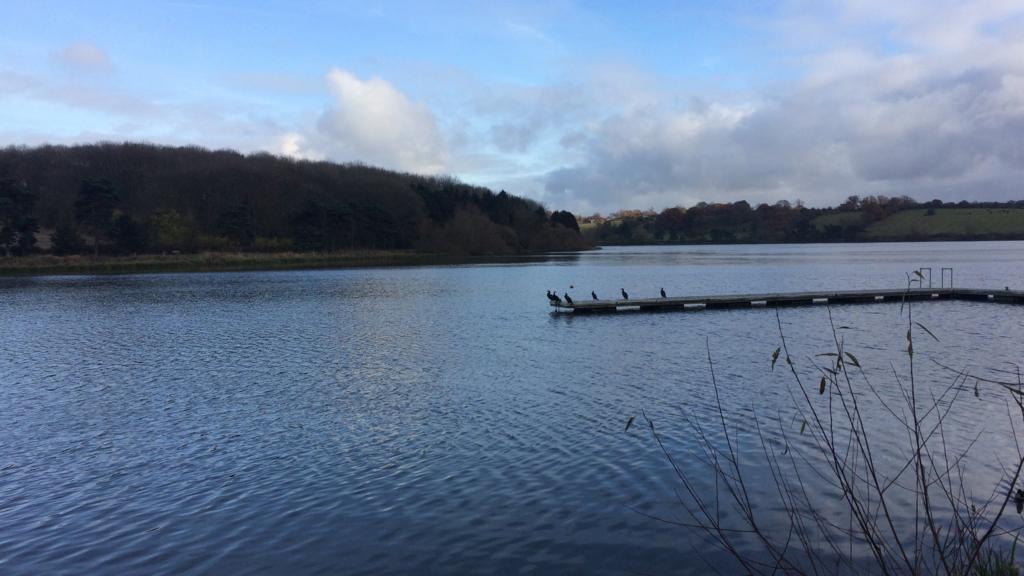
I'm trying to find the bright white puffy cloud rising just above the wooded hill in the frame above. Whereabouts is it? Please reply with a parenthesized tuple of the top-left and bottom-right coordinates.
(281, 69, 449, 174)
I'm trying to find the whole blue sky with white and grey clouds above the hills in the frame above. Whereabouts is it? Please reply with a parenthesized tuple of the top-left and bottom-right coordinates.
(0, 0, 1024, 214)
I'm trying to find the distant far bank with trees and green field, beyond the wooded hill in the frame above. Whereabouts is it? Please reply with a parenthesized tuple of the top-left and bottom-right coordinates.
(581, 196, 1024, 245)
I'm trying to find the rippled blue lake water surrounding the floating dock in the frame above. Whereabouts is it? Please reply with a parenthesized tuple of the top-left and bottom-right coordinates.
(0, 243, 1024, 574)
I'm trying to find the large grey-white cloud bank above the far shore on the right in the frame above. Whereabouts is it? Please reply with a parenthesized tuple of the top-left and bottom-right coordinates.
(545, 2, 1024, 210)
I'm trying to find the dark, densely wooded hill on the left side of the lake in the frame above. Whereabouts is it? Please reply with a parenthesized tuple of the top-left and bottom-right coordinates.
(0, 143, 588, 255)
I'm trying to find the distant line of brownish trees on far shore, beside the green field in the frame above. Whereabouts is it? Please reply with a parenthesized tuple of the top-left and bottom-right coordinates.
(581, 196, 1024, 244)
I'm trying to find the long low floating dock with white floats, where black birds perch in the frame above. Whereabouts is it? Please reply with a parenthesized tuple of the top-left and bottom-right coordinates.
(551, 288, 1024, 314)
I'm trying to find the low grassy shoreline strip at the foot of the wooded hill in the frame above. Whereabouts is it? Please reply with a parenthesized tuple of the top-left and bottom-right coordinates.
(0, 250, 581, 277)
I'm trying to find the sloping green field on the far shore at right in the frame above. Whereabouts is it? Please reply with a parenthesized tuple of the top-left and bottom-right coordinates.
(864, 208, 1024, 240)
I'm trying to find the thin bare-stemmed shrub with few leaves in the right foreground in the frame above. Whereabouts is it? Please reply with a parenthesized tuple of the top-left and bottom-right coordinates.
(643, 277, 1024, 576)
